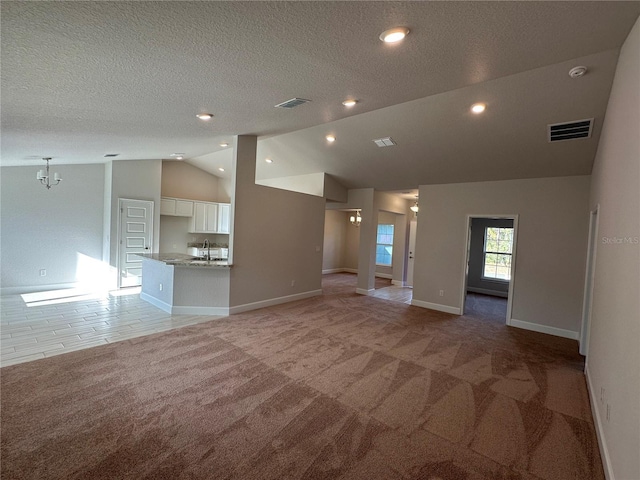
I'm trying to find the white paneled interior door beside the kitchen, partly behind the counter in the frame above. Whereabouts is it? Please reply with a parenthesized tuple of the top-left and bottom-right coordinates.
(118, 198, 153, 287)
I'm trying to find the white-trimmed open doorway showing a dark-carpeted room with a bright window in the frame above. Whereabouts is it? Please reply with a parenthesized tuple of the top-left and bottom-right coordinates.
(460, 215, 518, 325)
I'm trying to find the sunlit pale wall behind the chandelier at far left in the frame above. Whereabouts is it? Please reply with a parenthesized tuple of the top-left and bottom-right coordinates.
(0, 163, 105, 293)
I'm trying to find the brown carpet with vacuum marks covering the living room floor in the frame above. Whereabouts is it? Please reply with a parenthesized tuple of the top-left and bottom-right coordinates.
(0, 274, 604, 480)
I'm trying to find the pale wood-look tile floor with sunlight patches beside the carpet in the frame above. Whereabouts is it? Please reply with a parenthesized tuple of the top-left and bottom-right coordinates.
(0, 289, 221, 367)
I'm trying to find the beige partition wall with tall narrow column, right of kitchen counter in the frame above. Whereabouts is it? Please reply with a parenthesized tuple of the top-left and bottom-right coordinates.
(230, 136, 325, 311)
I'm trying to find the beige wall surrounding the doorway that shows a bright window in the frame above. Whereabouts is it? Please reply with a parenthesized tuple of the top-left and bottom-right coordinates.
(413, 176, 590, 338)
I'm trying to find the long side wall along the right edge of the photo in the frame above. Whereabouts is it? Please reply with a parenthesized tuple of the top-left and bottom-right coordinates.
(587, 15, 640, 480)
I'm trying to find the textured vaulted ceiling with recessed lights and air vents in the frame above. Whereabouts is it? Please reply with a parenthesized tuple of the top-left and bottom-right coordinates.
(1, 1, 640, 190)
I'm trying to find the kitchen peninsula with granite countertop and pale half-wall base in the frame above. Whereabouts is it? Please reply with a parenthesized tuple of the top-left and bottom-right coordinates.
(140, 253, 231, 315)
